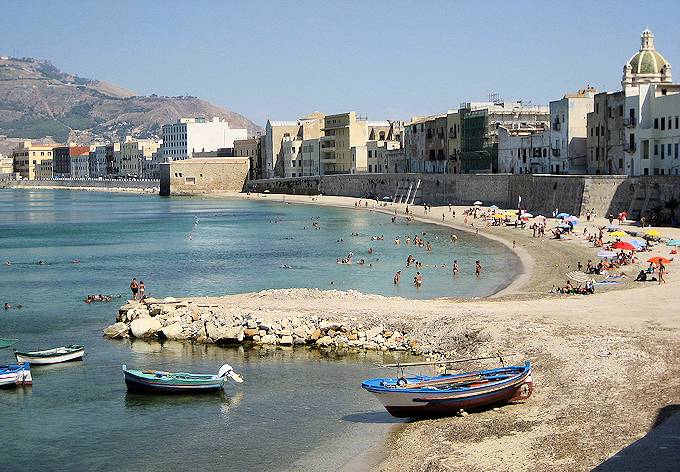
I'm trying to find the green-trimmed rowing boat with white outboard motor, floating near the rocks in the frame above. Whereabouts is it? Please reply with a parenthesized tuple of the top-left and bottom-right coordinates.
(123, 364, 243, 393)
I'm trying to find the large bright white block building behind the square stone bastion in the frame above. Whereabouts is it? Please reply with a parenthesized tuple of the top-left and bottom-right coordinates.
(162, 117, 248, 161)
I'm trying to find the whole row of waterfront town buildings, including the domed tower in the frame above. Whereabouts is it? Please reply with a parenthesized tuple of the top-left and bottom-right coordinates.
(0, 29, 680, 180)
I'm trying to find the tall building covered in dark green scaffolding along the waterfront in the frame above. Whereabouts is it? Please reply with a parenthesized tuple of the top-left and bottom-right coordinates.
(458, 100, 550, 174)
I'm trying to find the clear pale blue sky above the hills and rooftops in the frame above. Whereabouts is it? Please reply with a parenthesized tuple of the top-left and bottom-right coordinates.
(0, 0, 680, 126)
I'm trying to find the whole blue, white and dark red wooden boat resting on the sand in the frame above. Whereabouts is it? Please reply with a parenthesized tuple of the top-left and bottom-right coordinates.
(361, 361, 533, 418)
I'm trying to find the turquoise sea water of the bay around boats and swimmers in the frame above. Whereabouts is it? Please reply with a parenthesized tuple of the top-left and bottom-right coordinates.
(0, 190, 516, 470)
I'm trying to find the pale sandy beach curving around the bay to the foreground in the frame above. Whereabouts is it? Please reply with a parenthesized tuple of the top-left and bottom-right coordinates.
(197, 190, 680, 471)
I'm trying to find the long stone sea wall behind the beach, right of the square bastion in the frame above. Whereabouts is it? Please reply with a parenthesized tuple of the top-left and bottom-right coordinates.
(246, 174, 680, 218)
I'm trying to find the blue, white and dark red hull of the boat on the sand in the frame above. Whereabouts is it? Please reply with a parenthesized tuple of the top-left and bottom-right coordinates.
(362, 367, 533, 418)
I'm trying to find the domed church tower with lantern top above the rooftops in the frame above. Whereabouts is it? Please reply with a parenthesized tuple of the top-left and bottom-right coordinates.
(621, 29, 672, 89)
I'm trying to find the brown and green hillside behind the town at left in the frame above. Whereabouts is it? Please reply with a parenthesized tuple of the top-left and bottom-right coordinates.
(0, 57, 261, 144)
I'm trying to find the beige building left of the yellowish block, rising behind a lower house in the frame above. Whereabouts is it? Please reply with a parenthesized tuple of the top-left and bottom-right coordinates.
(260, 112, 324, 179)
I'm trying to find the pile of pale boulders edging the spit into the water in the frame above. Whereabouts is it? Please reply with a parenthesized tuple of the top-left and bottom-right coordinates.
(104, 298, 433, 354)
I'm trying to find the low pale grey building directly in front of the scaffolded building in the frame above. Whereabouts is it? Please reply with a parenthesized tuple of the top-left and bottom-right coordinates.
(498, 126, 554, 174)
